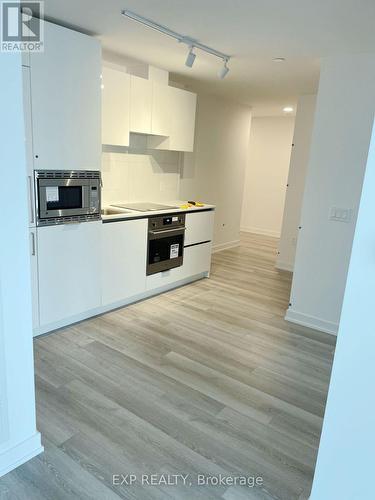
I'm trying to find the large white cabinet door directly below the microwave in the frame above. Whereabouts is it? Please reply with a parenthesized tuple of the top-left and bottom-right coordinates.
(38, 221, 102, 326)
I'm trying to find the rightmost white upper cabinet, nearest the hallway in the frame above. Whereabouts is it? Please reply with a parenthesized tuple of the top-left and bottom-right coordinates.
(148, 83, 197, 151)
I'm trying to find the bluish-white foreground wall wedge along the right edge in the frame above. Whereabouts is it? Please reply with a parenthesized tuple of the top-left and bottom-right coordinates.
(310, 118, 375, 500)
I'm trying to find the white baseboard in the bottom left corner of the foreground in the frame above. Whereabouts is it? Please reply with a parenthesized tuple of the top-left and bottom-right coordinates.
(0, 432, 44, 477)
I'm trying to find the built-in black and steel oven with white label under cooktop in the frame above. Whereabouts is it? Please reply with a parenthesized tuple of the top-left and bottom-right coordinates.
(146, 214, 185, 276)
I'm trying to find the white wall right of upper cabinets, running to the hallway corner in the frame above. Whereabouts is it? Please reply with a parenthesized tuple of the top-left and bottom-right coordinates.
(180, 94, 251, 249)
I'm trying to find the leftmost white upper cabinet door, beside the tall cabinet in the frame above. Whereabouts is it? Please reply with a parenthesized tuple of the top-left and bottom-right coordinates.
(102, 67, 130, 146)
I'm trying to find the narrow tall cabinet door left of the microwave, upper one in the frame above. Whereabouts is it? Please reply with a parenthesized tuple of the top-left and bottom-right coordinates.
(22, 66, 35, 227)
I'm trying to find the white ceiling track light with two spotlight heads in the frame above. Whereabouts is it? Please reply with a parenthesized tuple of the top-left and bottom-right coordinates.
(121, 10, 230, 80)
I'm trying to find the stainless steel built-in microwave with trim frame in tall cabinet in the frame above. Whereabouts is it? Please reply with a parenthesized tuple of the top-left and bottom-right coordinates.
(35, 170, 101, 226)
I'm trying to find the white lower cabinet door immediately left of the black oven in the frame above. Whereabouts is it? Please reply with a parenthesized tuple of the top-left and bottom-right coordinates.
(101, 219, 148, 306)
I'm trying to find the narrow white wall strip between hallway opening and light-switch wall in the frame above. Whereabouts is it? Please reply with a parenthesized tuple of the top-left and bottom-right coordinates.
(276, 95, 316, 271)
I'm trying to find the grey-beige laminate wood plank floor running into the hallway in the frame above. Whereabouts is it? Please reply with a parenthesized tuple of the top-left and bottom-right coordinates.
(0, 234, 335, 500)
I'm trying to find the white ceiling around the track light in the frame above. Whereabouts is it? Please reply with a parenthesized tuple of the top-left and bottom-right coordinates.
(45, 0, 375, 115)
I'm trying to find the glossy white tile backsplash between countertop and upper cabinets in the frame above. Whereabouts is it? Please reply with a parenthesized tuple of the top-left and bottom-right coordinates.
(102, 140, 180, 205)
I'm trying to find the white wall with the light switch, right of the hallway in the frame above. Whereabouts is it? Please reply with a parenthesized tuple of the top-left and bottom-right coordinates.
(286, 54, 375, 333)
